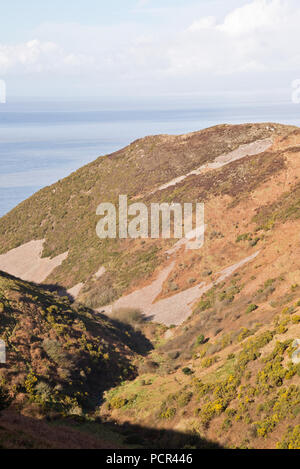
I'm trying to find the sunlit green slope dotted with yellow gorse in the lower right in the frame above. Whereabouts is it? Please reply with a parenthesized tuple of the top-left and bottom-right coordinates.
(101, 269, 300, 449)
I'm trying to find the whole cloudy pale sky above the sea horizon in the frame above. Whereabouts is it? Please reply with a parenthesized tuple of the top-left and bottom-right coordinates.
(0, 0, 300, 103)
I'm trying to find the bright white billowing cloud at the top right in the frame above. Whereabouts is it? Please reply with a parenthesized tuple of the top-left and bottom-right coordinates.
(169, 0, 300, 78)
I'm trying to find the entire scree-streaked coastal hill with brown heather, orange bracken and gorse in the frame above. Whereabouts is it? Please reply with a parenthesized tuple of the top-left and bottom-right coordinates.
(0, 123, 300, 448)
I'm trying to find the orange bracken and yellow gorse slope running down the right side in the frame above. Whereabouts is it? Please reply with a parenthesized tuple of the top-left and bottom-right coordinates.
(94, 122, 300, 449)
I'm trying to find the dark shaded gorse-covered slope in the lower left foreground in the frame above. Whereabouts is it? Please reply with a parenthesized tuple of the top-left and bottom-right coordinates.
(0, 272, 218, 449)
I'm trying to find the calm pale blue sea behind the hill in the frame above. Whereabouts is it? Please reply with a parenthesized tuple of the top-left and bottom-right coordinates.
(0, 99, 300, 217)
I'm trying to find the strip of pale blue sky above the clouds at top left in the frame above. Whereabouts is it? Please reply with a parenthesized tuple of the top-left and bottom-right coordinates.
(1, 0, 241, 43)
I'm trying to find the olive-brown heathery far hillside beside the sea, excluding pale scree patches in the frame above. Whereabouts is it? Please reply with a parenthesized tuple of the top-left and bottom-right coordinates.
(0, 124, 293, 306)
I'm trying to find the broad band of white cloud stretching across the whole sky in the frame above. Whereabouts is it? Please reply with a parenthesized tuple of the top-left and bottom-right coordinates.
(0, 0, 300, 94)
